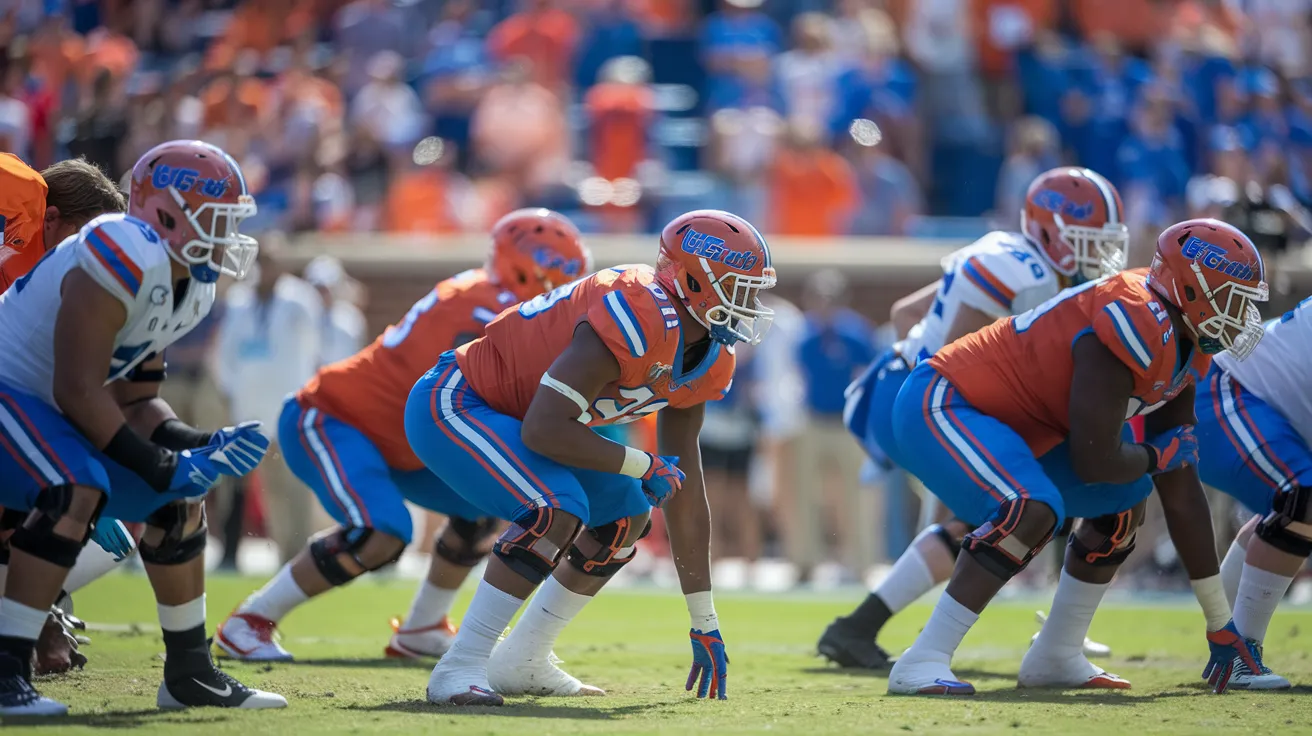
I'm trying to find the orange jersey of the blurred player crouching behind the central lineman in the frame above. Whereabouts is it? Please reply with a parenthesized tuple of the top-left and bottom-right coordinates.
(297, 269, 516, 470)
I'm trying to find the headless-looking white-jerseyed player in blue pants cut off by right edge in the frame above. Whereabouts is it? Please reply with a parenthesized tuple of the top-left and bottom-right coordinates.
(1194, 292, 1312, 690)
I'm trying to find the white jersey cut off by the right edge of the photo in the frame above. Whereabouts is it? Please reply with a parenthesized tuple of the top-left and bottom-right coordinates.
(1212, 296, 1312, 441)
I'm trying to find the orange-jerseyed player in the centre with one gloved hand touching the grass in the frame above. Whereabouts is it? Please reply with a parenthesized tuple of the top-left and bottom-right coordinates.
(405, 210, 775, 706)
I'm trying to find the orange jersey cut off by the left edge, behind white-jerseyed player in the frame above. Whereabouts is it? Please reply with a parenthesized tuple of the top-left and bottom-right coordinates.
(0, 153, 47, 294)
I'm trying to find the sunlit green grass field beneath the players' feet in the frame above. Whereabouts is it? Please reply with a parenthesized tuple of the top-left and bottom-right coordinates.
(4, 576, 1312, 736)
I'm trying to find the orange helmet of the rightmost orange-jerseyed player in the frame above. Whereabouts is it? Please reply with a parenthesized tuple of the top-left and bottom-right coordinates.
(1148, 219, 1267, 359)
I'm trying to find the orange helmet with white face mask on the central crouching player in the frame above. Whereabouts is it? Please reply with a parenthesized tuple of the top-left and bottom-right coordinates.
(656, 210, 775, 345)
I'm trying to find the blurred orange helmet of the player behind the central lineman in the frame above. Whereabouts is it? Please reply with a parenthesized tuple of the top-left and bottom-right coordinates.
(487, 207, 592, 302)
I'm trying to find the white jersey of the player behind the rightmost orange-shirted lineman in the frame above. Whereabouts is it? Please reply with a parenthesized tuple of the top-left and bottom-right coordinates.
(895, 231, 1060, 365)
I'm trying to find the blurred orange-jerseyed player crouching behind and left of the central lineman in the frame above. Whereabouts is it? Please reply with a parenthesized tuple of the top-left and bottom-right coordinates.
(215, 209, 592, 661)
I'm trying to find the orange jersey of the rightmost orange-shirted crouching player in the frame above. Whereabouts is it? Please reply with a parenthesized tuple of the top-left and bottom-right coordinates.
(929, 269, 1211, 455)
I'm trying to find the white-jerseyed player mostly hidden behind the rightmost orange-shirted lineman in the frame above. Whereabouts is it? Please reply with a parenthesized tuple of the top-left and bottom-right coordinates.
(816, 167, 1130, 669)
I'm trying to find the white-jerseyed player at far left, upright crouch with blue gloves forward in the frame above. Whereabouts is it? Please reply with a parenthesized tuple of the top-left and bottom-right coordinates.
(0, 142, 286, 715)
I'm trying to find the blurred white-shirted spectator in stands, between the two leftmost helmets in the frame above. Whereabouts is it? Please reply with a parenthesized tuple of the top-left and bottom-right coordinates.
(350, 51, 426, 150)
